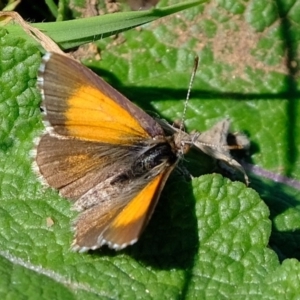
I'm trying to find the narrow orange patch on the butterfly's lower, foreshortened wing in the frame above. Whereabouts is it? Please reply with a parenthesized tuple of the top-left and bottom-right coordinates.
(110, 172, 164, 229)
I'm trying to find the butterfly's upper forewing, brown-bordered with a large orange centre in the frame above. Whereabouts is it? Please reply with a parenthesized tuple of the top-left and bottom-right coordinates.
(38, 53, 163, 145)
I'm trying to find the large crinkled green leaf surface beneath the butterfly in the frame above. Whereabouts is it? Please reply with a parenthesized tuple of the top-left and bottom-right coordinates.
(0, 1, 300, 299)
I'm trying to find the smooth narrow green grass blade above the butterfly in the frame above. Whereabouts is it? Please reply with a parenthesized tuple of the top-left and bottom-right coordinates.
(6, 0, 203, 49)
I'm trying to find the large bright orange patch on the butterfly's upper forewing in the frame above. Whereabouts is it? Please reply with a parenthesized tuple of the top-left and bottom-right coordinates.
(66, 86, 149, 144)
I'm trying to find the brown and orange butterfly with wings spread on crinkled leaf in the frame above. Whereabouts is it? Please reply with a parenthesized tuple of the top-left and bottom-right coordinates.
(34, 53, 246, 252)
